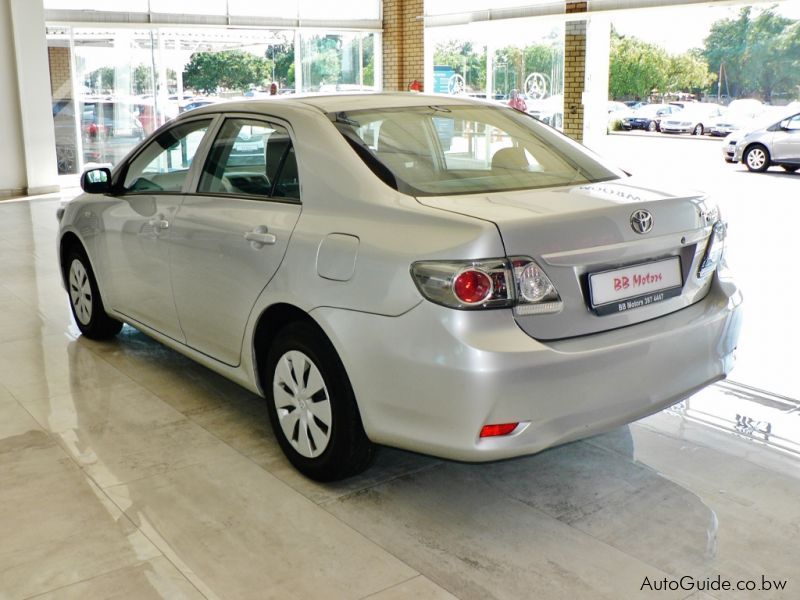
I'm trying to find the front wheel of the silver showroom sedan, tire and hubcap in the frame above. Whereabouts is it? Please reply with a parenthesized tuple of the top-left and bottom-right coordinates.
(64, 248, 122, 340)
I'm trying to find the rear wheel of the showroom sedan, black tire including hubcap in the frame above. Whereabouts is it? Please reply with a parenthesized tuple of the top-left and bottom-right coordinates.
(261, 322, 374, 481)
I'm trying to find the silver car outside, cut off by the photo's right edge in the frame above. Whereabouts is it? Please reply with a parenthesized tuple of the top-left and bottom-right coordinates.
(731, 113, 800, 173)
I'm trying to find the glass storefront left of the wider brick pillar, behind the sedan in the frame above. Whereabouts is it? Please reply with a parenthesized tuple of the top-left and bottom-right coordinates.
(47, 25, 380, 174)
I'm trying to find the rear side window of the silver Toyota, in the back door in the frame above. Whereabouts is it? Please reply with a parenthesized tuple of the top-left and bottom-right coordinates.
(197, 118, 300, 199)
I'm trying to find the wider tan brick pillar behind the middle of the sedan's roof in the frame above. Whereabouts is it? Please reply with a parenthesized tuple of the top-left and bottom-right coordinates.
(383, 0, 425, 92)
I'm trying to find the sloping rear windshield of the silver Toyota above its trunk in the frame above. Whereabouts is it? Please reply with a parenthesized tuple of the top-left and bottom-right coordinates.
(329, 106, 622, 196)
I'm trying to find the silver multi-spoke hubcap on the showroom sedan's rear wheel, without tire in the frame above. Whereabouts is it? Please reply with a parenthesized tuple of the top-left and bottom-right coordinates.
(272, 350, 331, 458)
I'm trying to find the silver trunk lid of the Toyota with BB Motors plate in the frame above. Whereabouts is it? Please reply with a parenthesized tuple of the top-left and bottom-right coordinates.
(418, 179, 717, 340)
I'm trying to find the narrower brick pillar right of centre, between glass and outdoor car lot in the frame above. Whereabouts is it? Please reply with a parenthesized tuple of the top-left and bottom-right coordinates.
(564, 2, 586, 142)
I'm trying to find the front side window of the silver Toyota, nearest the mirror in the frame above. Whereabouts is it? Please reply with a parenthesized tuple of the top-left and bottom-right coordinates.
(123, 119, 211, 193)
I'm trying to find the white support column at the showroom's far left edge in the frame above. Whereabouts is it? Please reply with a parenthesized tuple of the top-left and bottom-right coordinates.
(8, 0, 60, 194)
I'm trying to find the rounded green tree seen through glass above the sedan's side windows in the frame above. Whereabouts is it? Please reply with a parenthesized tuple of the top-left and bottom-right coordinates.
(183, 50, 272, 94)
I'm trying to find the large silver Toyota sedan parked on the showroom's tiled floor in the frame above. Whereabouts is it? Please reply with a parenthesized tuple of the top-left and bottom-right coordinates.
(59, 94, 741, 480)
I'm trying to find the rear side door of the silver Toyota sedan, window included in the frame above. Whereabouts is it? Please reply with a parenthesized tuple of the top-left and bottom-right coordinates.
(171, 115, 301, 366)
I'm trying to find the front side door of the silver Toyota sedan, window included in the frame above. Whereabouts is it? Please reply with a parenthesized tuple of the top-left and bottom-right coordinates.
(98, 117, 212, 341)
